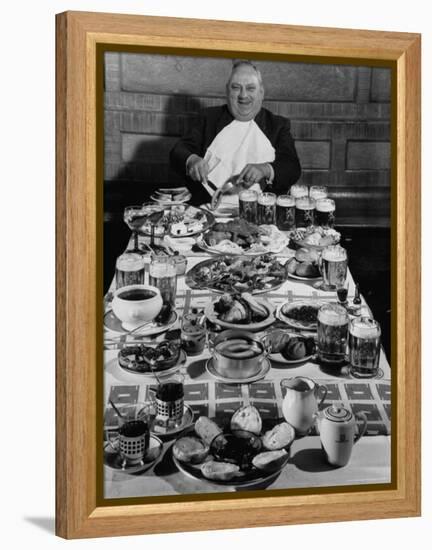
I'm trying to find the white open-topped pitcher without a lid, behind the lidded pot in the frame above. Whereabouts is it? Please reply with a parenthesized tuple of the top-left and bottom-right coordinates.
(280, 376, 327, 434)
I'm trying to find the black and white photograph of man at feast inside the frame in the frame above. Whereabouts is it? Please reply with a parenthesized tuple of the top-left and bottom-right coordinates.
(100, 49, 394, 504)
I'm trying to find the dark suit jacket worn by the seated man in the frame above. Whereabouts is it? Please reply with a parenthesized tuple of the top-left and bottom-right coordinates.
(170, 105, 301, 202)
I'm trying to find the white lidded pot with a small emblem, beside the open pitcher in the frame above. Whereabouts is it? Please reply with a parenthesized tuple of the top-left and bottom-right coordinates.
(318, 403, 367, 466)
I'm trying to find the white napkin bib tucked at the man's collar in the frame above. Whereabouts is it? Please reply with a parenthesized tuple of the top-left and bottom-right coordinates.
(203, 120, 275, 206)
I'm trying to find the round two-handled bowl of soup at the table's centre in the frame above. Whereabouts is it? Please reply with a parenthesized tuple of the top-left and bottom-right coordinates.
(212, 330, 267, 379)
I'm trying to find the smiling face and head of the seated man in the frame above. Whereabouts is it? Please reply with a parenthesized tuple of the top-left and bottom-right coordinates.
(227, 66, 264, 121)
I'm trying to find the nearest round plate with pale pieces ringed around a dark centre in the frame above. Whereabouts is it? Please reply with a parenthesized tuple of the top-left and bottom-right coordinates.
(172, 405, 295, 487)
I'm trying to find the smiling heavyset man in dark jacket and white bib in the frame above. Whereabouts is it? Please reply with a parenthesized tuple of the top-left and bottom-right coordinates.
(170, 61, 301, 204)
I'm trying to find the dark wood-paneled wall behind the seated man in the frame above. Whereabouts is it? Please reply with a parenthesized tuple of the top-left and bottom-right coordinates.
(105, 53, 390, 226)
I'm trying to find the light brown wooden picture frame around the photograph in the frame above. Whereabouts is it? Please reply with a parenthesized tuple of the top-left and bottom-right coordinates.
(56, 12, 421, 538)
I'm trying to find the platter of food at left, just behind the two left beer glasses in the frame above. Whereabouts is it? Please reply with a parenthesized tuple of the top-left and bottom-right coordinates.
(139, 203, 215, 238)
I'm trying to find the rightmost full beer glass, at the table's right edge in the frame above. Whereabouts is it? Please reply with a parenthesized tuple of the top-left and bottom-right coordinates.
(348, 317, 381, 378)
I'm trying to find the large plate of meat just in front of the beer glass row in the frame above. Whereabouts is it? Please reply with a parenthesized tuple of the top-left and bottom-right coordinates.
(197, 218, 289, 256)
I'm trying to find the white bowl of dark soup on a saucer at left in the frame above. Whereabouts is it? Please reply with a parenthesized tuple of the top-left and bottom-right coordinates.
(112, 285, 162, 330)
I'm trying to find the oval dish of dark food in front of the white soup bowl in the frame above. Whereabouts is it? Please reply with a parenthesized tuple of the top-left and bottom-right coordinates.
(118, 340, 186, 376)
